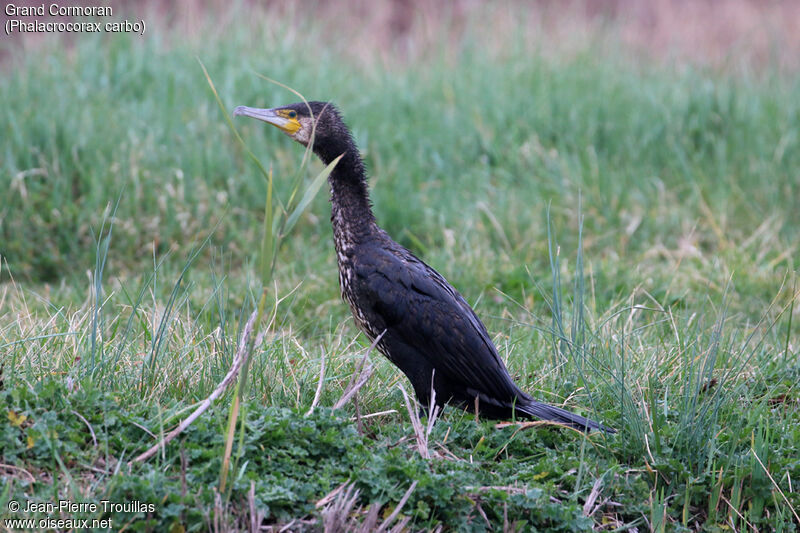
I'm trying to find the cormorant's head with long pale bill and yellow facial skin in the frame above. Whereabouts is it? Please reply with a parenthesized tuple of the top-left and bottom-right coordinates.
(233, 102, 349, 151)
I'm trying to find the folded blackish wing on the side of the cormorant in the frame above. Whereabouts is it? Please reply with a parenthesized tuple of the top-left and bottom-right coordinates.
(353, 245, 520, 399)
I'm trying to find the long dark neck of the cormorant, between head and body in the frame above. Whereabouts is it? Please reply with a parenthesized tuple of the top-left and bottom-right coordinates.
(317, 138, 377, 248)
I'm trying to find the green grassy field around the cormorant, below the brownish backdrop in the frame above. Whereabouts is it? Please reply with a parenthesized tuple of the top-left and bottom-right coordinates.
(0, 2, 800, 532)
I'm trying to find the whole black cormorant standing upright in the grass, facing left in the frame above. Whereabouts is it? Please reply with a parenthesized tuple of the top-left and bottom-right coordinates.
(233, 102, 614, 432)
